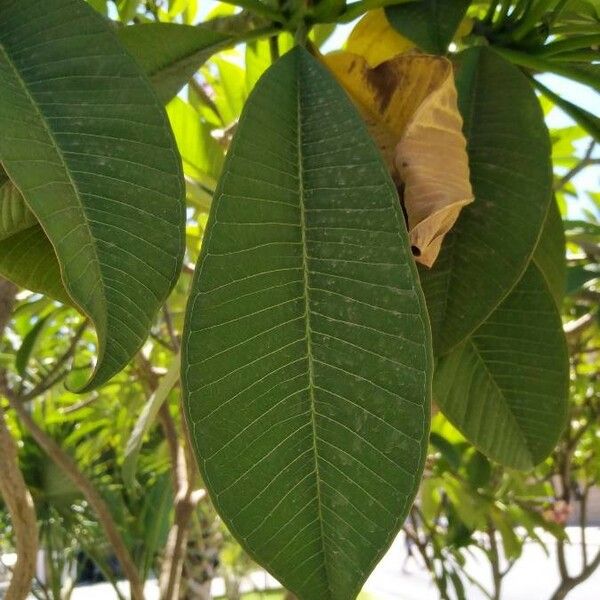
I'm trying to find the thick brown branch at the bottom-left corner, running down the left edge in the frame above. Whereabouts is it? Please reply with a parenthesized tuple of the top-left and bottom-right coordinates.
(0, 407, 38, 600)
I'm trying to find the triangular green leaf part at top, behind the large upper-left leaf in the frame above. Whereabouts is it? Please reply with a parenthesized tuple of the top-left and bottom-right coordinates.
(118, 23, 233, 104)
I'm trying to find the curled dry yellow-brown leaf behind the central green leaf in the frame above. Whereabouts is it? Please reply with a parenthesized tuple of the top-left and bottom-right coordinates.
(323, 52, 473, 267)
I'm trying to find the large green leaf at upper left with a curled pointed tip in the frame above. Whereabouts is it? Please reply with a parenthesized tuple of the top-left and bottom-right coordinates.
(0, 0, 185, 389)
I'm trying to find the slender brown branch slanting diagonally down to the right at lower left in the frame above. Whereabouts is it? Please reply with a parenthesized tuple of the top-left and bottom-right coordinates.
(0, 382, 144, 600)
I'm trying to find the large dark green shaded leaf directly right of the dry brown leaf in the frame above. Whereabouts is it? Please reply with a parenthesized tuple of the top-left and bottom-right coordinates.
(420, 47, 552, 354)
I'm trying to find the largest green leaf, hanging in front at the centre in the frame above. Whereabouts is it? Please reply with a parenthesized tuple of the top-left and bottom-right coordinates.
(182, 48, 432, 600)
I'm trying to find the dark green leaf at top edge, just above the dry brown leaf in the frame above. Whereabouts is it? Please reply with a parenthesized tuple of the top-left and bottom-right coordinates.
(385, 0, 471, 54)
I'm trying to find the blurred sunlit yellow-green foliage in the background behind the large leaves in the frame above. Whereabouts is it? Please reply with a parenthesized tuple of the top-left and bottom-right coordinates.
(0, 0, 600, 600)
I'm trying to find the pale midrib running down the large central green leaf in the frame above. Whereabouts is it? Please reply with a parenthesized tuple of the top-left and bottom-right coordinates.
(296, 63, 332, 595)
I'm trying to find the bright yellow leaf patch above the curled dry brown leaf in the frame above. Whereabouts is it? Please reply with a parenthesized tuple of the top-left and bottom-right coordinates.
(346, 8, 415, 67)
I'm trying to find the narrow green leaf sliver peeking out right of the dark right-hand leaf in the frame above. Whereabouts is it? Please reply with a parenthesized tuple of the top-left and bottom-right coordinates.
(533, 200, 567, 309)
